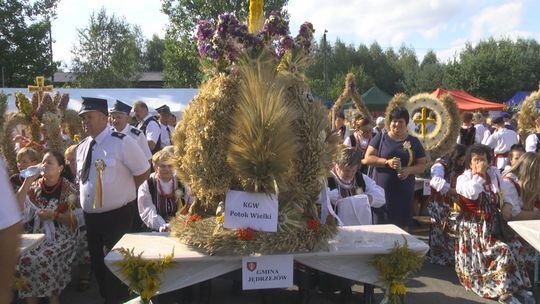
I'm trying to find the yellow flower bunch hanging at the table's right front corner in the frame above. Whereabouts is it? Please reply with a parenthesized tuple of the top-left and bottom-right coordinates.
(371, 237, 424, 304)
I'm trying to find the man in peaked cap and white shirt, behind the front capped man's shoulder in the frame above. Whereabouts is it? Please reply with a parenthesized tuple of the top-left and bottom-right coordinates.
(109, 100, 152, 162)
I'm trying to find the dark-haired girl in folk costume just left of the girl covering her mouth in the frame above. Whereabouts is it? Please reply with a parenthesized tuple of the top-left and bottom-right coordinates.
(428, 144, 467, 265)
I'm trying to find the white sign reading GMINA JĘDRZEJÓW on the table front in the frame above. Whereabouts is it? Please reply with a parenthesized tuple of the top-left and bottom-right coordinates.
(242, 255, 293, 290)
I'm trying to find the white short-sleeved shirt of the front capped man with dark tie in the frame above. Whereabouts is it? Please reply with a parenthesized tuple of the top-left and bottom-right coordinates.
(76, 128, 150, 213)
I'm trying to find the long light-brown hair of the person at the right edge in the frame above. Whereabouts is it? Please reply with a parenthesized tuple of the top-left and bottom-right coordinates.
(508, 152, 540, 211)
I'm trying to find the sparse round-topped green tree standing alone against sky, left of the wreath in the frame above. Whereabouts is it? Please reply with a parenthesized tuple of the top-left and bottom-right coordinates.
(72, 8, 143, 88)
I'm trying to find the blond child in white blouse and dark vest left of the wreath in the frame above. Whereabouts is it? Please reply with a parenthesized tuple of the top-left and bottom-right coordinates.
(137, 150, 190, 231)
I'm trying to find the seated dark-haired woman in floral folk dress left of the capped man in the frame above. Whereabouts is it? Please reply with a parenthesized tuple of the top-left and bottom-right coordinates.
(17, 152, 80, 304)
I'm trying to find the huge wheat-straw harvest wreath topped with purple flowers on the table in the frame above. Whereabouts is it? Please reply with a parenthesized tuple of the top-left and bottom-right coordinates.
(170, 1, 337, 255)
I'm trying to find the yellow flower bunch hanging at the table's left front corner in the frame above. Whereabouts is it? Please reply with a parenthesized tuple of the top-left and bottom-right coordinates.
(113, 247, 174, 303)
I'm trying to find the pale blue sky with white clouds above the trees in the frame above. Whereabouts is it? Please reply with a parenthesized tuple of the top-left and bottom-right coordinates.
(52, 0, 540, 64)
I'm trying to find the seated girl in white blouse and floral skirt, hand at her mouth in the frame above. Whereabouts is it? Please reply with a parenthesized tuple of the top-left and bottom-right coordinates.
(455, 144, 534, 304)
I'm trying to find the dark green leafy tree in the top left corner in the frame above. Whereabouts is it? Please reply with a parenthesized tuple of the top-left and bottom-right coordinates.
(0, 0, 59, 87)
